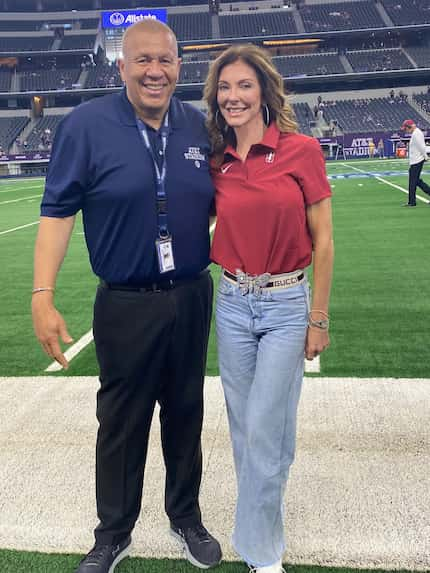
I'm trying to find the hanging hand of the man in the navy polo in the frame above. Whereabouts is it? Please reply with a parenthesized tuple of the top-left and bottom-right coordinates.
(31, 292, 73, 369)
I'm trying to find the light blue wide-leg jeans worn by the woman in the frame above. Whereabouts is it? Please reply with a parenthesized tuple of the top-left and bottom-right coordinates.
(216, 277, 309, 567)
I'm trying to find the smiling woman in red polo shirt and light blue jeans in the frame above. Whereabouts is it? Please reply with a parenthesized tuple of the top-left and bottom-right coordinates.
(204, 45, 333, 573)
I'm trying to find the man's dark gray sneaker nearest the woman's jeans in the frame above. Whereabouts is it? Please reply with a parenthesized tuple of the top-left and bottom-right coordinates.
(170, 523, 222, 569)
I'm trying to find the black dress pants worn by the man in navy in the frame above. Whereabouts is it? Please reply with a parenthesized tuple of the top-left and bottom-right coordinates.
(93, 271, 213, 544)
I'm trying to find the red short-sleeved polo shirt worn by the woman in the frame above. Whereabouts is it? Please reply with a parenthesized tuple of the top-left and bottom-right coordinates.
(211, 123, 331, 275)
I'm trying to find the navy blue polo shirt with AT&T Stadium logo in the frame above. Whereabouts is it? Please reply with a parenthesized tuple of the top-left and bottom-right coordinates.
(41, 90, 214, 284)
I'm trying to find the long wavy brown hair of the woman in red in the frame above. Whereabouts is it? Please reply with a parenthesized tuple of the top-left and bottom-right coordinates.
(203, 44, 297, 161)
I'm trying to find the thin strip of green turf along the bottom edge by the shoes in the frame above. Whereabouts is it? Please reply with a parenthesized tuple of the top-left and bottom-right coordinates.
(0, 550, 414, 573)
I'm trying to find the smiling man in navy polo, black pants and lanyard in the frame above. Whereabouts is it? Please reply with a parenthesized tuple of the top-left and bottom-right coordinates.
(32, 17, 221, 573)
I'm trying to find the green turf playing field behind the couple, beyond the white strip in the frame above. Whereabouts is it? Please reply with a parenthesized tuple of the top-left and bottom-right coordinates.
(0, 160, 430, 378)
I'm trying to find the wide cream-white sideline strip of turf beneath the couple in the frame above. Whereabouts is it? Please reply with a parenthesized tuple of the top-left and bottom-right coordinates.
(0, 377, 430, 570)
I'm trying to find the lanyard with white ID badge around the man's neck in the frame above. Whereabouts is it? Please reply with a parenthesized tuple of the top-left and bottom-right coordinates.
(138, 114, 175, 273)
